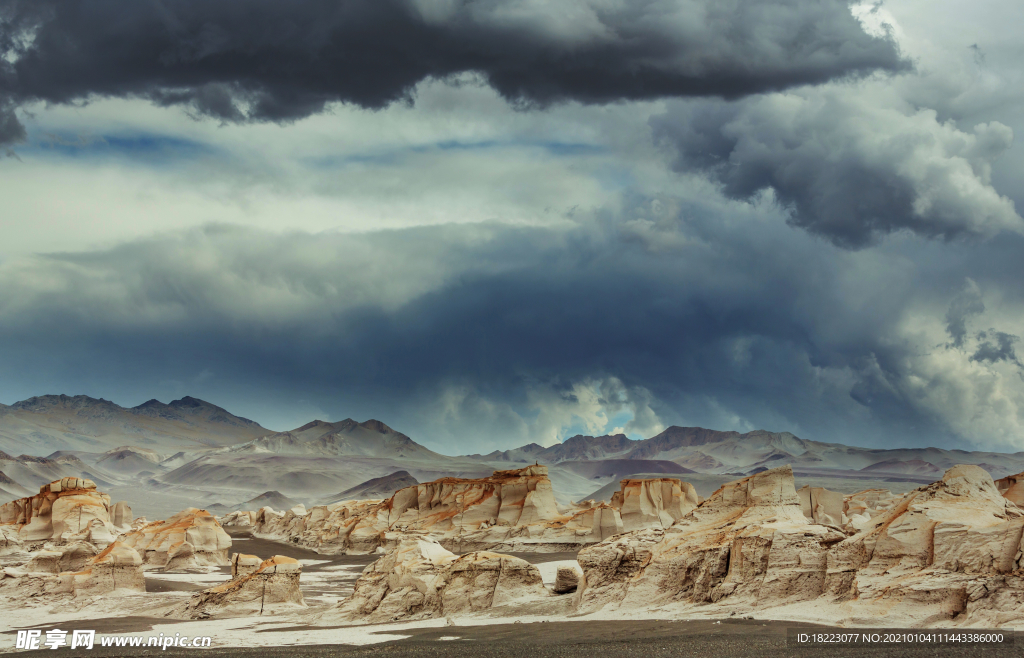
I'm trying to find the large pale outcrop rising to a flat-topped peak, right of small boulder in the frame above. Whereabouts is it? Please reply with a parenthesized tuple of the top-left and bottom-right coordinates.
(578, 467, 846, 612)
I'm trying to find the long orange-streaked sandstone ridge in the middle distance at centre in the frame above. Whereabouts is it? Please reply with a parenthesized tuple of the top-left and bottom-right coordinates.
(252, 466, 698, 554)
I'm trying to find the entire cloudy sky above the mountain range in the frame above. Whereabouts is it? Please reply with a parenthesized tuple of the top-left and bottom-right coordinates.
(0, 0, 1024, 454)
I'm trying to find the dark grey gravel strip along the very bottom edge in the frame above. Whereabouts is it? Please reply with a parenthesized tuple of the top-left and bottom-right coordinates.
(8, 620, 1024, 658)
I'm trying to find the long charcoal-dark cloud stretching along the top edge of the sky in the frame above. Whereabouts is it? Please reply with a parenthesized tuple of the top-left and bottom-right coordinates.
(0, 0, 908, 141)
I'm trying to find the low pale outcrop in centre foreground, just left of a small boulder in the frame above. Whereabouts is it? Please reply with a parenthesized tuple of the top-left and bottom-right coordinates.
(329, 538, 551, 623)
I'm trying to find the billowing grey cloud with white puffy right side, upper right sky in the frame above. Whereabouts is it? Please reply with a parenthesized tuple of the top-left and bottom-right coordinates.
(652, 92, 1024, 249)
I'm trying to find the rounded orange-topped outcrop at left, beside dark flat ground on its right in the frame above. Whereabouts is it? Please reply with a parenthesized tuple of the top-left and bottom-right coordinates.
(121, 508, 231, 570)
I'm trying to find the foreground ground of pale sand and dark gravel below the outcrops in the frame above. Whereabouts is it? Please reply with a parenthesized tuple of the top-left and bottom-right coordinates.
(0, 532, 1024, 658)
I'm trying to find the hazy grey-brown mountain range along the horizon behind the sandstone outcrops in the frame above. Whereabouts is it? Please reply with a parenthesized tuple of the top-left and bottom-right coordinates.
(0, 395, 1024, 515)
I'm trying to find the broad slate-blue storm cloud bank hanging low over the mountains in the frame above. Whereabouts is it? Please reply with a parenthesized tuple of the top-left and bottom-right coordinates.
(0, 200, 1024, 451)
